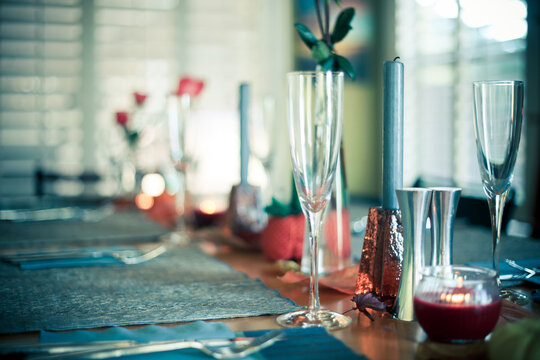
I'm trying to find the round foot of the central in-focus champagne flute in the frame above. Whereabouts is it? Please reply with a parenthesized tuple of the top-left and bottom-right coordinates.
(277, 309, 351, 330)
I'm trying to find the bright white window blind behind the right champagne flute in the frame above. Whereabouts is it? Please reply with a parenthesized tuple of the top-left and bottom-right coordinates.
(396, 0, 527, 200)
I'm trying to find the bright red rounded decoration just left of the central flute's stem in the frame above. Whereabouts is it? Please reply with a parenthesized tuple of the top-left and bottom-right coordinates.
(261, 214, 305, 260)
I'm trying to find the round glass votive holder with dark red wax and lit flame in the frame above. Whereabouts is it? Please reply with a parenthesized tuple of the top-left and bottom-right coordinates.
(414, 265, 501, 343)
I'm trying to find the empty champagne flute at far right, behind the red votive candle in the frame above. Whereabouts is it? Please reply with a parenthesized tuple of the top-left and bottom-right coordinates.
(473, 81, 526, 303)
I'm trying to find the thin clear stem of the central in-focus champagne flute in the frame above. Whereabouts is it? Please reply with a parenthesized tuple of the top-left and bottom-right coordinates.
(307, 210, 324, 312)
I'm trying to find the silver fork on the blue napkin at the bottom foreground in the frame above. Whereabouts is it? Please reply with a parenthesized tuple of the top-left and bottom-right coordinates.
(27, 330, 283, 360)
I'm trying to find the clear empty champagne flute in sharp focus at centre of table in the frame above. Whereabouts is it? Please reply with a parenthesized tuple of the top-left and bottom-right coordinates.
(277, 71, 351, 329)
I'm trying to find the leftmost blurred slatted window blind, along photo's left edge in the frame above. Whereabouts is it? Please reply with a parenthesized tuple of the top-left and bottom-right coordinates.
(0, 0, 83, 205)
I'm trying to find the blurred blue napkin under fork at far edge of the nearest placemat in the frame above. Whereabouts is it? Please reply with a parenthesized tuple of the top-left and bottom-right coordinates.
(10, 246, 138, 270)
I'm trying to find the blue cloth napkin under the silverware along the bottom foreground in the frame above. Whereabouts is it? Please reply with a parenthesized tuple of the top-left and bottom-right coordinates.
(40, 321, 367, 360)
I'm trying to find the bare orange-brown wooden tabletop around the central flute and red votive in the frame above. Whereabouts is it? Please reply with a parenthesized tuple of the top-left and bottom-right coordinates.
(206, 239, 539, 360)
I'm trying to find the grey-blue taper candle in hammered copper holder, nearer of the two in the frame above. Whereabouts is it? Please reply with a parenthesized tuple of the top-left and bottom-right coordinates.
(382, 58, 404, 209)
